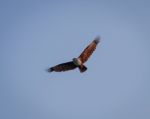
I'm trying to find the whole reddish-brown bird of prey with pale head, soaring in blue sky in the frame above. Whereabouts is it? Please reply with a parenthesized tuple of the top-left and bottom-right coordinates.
(48, 37, 100, 73)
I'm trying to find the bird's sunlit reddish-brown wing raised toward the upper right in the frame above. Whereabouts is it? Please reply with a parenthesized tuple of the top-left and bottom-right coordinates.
(78, 37, 100, 63)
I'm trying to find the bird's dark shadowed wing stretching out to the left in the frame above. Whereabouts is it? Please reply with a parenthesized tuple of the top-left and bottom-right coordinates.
(48, 61, 77, 72)
